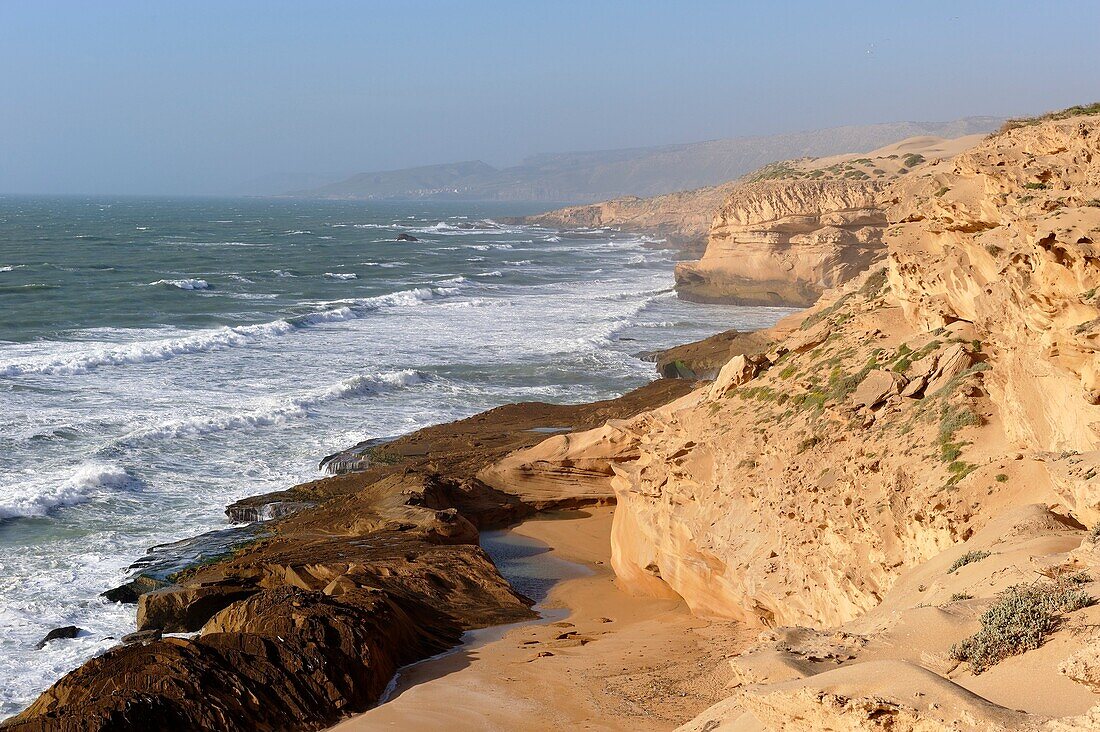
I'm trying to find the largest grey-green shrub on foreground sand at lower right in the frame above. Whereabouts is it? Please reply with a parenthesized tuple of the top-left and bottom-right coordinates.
(950, 579, 1096, 675)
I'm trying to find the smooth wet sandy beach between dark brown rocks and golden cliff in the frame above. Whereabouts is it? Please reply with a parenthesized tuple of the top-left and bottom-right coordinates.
(334, 507, 757, 732)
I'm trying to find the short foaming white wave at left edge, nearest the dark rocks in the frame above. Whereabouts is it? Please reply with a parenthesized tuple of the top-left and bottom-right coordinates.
(0, 462, 140, 518)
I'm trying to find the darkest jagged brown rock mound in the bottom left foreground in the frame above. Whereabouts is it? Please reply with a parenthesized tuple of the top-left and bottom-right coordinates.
(4, 587, 460, 732)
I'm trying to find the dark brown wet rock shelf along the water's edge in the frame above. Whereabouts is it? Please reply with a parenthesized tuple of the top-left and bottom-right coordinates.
(0, 380, 693, 732)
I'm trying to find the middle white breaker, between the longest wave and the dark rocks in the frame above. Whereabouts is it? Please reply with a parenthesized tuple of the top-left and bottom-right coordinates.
(119, 369, 430, 445)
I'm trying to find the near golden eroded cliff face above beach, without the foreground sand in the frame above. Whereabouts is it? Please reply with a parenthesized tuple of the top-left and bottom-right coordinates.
(612, 118, 1100, 625)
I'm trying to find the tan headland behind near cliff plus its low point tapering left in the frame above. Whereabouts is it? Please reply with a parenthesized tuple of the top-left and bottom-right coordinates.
(524, 135, 981, 307)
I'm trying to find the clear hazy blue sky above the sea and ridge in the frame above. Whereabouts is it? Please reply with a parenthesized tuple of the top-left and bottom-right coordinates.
(0, 0, 1100, 195)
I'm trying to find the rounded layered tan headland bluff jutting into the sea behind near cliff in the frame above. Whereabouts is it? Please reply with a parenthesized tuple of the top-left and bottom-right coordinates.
(677, 136, 978, 307)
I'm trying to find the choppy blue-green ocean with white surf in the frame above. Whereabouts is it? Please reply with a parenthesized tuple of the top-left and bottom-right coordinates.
(0, 197, 787, 718)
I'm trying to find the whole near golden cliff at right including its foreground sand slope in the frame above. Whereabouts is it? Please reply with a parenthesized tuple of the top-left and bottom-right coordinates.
(497, 116, 1100, 731)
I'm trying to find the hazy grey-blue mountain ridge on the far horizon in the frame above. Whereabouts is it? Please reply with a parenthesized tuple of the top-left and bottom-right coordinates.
(285, 117, 1003, 203)
